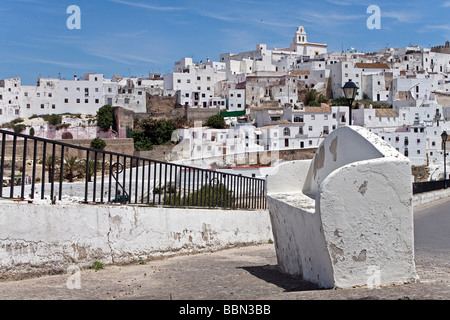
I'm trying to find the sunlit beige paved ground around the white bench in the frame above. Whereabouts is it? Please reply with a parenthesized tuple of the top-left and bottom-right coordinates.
(0, 198, 450, 300)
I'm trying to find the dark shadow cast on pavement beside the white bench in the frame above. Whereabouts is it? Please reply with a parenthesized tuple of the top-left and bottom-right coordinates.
(238, 265, 326, 292)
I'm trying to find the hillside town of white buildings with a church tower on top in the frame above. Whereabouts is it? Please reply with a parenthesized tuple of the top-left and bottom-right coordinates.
(0, 26, 450, 180)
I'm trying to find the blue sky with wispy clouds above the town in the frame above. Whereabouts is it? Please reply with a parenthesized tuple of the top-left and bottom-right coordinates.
(0, 0, 450, 85)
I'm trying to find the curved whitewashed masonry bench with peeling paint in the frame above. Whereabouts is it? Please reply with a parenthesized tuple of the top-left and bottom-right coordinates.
(267, 126, 418, 288)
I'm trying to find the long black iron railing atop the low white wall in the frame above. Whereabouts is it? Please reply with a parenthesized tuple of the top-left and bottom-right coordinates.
(0, 129, 267, 209)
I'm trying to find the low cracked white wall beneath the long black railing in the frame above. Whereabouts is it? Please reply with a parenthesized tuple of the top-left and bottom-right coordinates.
(0, 200, 273, 278)
